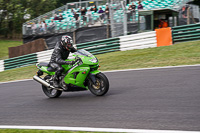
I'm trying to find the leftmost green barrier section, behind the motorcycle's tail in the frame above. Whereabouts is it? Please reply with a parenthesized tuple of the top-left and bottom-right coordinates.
(4, 53, 37, 70)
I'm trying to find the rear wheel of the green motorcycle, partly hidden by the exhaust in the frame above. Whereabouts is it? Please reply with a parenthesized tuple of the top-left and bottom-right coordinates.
(42, 75, 62, 98)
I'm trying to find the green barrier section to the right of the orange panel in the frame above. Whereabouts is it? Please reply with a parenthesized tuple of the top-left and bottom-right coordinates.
(172, 23, 200, 42)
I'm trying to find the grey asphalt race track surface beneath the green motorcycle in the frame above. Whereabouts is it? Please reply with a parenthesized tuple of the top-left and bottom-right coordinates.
(0, 66, 200, 131)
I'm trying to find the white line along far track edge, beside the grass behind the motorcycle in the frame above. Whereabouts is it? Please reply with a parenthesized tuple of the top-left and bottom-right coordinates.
(0, 64, 200, 84)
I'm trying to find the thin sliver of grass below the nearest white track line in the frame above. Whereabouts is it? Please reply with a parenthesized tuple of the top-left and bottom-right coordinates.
(0, 129, 108, 133)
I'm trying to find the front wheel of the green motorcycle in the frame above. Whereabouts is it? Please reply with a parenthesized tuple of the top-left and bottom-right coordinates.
(88, 73, 109, 96)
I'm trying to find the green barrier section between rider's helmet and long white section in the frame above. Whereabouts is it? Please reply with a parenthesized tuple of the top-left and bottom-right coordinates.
(76, 38, 120, 54)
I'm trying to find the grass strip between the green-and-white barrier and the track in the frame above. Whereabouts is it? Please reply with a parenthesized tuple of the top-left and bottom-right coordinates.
(0, 41, 200, 82)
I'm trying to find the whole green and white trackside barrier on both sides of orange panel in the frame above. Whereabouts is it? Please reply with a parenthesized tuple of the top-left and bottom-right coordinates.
(0, 24, 200, 72)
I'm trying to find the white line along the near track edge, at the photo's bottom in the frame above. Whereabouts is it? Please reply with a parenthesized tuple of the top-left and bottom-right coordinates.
(0, 125, 200, 133)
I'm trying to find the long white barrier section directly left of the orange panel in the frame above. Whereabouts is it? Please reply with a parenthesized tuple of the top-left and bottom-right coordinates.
(119, 31, 157, 51)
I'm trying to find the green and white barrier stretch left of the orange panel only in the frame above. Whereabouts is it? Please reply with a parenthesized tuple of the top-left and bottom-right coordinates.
(0, 31, 156, 71)
